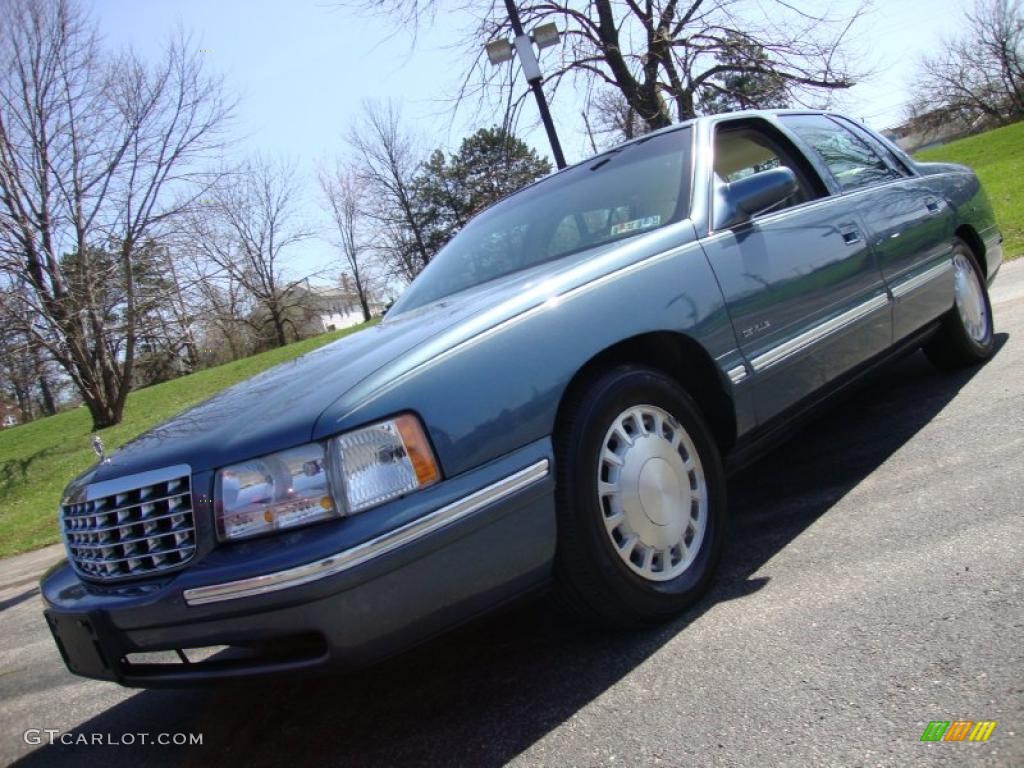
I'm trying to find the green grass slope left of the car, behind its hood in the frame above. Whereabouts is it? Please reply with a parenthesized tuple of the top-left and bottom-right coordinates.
(0, 326, 376, 557)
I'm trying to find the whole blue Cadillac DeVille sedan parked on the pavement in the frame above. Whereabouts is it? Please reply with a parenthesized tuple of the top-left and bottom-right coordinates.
(42, 111, 1002, 686)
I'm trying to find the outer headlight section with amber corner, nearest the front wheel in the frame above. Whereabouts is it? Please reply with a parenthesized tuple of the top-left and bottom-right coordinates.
(332, 414, 441, 514)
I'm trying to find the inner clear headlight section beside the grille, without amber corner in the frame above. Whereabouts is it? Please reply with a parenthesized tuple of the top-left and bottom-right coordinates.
(214, 443, 338, 539)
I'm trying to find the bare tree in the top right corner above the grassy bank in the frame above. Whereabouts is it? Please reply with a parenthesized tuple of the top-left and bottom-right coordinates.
(910, 0, 1024, 127)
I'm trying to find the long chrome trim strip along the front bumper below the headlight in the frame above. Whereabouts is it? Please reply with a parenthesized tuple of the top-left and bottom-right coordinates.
(184, 459, 550, 605)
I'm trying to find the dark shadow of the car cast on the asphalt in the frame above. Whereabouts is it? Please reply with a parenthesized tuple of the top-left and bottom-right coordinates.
(17, 334, 1007, 767)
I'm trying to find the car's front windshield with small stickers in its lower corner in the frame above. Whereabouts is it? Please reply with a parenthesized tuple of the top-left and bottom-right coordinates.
(392, 127, 690, 313)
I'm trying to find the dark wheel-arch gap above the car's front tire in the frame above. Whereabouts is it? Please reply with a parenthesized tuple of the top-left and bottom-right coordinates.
(555, 331, 736, 455)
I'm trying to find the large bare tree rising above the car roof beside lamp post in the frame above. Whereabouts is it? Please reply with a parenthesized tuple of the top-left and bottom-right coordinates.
(355, 0, 864, 128)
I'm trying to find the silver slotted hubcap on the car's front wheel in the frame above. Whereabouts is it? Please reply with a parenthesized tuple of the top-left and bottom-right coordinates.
(597, 406, 708, 582)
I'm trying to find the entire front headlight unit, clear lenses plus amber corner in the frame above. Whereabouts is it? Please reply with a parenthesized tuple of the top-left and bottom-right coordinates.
(214, 414, 440, 540)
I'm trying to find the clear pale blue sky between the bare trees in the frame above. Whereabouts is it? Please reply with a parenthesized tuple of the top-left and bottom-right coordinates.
(91, 0, 965, 276)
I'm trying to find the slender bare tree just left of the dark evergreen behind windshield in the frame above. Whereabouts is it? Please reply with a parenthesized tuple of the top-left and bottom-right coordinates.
(348, 102, 430, 282)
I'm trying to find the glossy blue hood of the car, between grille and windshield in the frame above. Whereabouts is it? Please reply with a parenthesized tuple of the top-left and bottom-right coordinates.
(73, 221, 693, 486)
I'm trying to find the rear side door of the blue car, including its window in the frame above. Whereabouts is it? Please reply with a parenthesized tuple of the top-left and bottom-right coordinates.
(780, 115, 955, 341)
